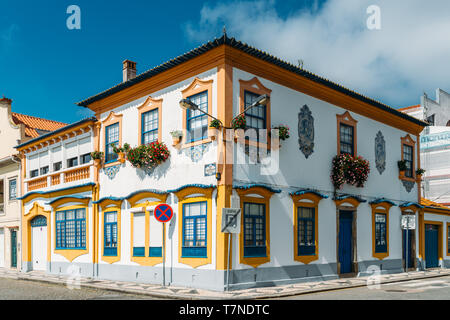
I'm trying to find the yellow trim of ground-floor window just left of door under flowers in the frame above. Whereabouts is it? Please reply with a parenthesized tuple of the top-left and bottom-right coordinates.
(291, 193, 322, 264)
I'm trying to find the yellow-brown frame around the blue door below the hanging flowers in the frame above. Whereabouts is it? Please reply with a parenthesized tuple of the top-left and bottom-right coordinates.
(336, 199, 359, 278)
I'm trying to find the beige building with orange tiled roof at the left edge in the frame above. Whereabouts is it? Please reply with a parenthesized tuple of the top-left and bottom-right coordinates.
(0, 97, 66, 268)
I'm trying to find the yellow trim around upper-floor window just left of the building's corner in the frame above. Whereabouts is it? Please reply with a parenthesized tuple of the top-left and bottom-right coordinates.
(181, 78, 214, 149)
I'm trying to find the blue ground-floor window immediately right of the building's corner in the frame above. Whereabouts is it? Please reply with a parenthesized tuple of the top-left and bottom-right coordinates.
(244, 202, 267, 257)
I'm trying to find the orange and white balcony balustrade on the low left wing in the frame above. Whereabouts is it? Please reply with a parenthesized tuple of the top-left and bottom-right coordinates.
(24, 164, 94, 194)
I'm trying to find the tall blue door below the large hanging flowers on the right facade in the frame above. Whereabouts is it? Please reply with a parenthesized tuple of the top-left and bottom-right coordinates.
(339, 211, 353, 273)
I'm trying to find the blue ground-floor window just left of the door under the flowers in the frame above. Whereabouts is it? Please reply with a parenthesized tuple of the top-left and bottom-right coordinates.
(297, 207, 316, 256)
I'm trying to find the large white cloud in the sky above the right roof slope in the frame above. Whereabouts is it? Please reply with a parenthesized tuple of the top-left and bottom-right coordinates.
(186, 0, 450, 107)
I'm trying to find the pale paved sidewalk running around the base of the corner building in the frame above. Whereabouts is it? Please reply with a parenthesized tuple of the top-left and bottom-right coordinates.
(0, 268, 450, 300)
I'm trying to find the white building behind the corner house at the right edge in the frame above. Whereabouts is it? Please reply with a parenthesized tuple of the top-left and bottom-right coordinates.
(399, 89, 450, 206)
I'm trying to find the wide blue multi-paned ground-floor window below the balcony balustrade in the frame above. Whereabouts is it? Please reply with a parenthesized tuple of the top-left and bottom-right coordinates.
(56, 208, 86, 249)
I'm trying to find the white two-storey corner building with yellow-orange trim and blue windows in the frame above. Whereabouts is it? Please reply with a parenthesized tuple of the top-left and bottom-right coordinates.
(16, 35, 450, 290)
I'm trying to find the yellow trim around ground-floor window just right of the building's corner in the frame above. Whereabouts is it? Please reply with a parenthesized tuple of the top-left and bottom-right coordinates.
(236, 187, 273, 268)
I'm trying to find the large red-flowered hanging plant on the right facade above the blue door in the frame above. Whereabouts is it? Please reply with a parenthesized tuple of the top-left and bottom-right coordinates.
(331, 154, 370, 190)
